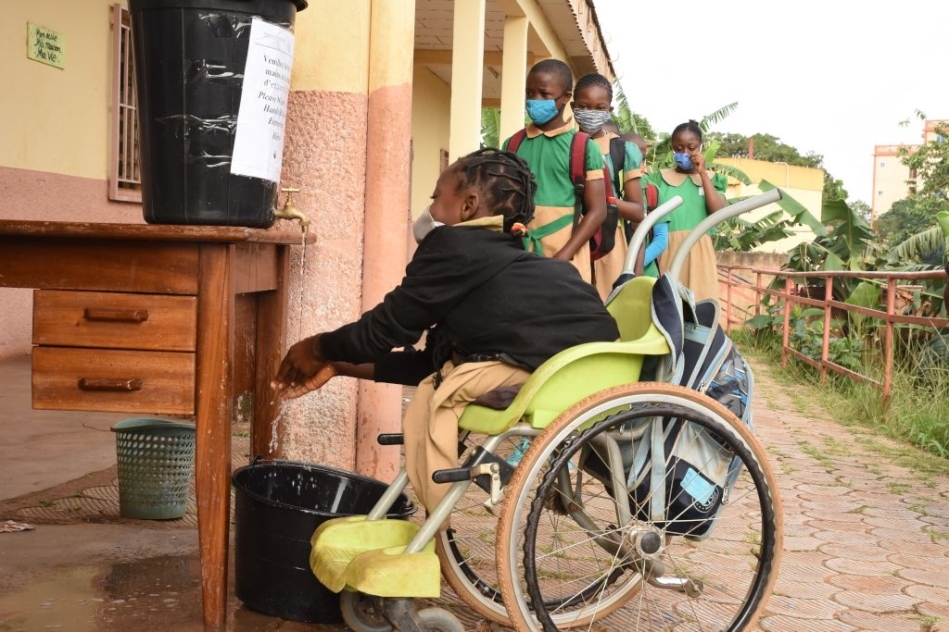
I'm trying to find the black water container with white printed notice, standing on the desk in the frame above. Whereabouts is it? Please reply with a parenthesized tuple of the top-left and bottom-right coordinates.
(129, 0, 307, 227)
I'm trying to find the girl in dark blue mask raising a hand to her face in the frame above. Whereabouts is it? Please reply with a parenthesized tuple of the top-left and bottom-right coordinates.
(644, 120, 728, 301)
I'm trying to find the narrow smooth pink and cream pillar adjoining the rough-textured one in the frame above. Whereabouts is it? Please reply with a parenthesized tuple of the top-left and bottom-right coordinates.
(356, 0, 414, 481)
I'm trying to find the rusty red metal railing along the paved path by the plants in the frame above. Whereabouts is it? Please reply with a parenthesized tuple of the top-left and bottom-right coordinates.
(719, 265, 949, 405)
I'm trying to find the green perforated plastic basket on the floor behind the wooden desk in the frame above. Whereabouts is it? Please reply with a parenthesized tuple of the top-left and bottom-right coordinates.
(112, 419, 194, 520)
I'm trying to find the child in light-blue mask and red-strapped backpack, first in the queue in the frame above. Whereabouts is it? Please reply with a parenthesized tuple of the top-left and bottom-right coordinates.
(502, 59, 606, 282)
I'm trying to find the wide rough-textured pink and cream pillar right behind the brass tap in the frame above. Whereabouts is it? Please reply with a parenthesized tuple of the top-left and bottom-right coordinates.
(276, 0, 370, 470)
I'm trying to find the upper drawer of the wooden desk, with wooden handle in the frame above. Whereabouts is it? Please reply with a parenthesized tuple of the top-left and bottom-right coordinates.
(33, 290, 197, 351)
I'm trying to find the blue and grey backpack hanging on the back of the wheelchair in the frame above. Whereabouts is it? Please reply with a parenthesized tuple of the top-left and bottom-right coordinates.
(582, 276, 754, 539)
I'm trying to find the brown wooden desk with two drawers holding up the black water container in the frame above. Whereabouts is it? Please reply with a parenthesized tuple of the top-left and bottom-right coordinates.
(0, 220, 313, 626)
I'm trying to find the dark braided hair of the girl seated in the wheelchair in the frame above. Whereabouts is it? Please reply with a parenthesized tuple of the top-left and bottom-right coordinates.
(455, 147, 537, 234)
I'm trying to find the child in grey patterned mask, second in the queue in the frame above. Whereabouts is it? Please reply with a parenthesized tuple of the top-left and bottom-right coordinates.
(571, 73, 644, 300)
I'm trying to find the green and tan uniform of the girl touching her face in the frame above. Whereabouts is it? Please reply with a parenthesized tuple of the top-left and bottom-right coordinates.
(646, 169, 728, 301)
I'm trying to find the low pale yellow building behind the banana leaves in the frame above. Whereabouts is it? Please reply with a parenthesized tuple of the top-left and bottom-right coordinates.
(715, 158, 824, 252)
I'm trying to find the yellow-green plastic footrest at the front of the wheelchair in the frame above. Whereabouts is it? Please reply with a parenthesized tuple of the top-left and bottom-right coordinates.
(310, 516, 441, 598)
